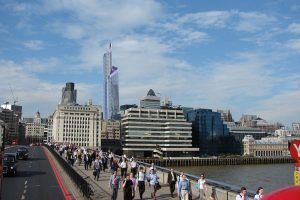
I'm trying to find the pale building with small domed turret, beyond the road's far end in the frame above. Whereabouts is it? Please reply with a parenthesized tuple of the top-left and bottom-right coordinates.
(23, 111, 48, 143)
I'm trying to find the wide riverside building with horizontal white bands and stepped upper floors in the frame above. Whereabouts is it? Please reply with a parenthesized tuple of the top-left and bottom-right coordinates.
(121, 108, 199, 157)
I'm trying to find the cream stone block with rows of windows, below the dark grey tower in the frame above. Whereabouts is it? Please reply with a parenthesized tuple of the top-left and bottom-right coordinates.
(52, 105, 101, 147)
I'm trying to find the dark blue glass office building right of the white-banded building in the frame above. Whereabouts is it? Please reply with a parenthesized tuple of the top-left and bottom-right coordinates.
(186, 108, 240, 155)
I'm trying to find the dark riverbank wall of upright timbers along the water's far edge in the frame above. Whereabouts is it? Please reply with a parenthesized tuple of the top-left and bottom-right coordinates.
(138, 157, 294, 167)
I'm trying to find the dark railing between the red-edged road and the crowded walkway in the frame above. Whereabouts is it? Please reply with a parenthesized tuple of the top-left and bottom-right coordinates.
(43, 144, 92, 198)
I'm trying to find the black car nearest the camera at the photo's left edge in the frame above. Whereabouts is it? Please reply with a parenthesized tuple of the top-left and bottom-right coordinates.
(3, 153, 17, 176)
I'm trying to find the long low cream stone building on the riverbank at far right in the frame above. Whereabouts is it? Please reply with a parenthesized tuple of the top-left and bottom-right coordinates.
(243, 135, 295, 157)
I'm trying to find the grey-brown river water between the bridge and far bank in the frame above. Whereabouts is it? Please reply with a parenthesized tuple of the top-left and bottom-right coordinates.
(174, 164, 294, 194)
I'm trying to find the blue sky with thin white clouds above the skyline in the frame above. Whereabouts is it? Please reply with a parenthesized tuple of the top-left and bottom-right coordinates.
(0, 0, 300, 126)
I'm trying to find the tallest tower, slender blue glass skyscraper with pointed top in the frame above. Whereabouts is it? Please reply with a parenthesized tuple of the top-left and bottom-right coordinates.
(103, 44, 120, 119)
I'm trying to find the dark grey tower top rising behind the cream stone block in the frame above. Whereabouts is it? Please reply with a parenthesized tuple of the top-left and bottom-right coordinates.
(60, 82, 77, 105)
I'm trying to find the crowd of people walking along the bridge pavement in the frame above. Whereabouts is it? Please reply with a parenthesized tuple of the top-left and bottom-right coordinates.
(52, 144, 263, 200)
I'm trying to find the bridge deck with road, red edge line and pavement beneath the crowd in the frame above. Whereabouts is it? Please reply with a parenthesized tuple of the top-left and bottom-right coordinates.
(2, 146, 254, 200)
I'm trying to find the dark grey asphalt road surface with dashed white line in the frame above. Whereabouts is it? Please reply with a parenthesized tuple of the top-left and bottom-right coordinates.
(2, 146, 65, 200)
